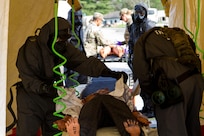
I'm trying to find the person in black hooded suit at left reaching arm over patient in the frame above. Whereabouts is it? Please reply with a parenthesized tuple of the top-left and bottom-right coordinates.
(16, 17, 127, 136)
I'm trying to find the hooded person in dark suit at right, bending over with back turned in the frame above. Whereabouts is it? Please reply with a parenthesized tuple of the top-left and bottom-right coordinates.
(133, 27, 204, 136)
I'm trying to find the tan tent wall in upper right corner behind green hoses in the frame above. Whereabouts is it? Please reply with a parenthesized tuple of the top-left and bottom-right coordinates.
(168, 0, 204, 72)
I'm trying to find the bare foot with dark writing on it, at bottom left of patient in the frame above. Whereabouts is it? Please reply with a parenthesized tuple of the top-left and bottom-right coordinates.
(65, 118, 80, 136)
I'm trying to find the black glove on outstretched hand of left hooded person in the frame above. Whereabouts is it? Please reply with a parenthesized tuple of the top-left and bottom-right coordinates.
(101, 69, 128, 84)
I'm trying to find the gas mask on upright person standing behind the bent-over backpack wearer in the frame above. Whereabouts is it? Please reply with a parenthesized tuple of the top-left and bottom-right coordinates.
(132, 5, 146, 23)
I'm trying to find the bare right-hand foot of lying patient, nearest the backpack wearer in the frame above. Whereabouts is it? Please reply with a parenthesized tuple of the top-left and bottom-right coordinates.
(123, 119, 140, 136)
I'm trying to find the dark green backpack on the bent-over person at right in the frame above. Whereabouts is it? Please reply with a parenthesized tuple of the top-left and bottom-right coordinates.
(145, 26, 201, 72)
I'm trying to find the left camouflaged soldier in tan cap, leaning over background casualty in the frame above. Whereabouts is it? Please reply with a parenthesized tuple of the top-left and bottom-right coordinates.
(84, 12, 120, 58)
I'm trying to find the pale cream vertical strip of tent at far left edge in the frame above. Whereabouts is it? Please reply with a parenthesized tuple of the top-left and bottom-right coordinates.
(0, 0, 9, 136)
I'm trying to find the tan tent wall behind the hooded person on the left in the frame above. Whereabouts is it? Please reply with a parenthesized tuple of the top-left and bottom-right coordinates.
(5, 0, 54, 134)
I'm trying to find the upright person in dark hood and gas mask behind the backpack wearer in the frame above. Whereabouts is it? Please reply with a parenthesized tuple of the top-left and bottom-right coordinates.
(128, 3, 155, 117)
